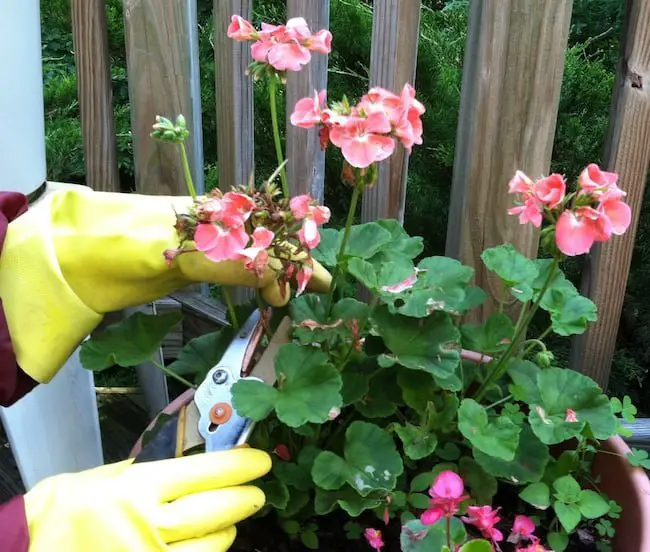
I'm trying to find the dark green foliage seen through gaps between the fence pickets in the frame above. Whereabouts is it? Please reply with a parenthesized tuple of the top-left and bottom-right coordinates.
(41, 0, 650, 405)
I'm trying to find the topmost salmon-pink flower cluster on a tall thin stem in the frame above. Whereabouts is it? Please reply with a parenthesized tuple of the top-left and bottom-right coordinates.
(228, 15, 332, 71)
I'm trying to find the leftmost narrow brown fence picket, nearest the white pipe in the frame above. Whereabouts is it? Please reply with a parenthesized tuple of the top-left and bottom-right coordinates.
(70, 0, 120, 192)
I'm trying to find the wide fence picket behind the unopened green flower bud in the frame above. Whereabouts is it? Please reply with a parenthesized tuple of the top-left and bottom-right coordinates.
(124, 0, 203, 195)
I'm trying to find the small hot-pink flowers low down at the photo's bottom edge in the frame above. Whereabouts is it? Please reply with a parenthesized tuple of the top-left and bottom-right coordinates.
(364, 470, 547, 552)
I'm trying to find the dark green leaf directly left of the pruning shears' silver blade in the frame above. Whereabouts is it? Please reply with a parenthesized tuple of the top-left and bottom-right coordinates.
(167, 328, 233, 383)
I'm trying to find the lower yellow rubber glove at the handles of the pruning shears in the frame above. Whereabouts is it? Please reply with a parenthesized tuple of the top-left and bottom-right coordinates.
(25, 448, 271, 552)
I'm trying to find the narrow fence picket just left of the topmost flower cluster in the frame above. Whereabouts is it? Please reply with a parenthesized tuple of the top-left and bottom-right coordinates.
(214, 0, 255, 303)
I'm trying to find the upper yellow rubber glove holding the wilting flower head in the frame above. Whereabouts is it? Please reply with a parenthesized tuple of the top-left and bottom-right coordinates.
(0, 186, 331, 383)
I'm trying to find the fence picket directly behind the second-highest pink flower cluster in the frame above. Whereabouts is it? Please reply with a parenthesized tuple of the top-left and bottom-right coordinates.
(361, 0, 422, 222)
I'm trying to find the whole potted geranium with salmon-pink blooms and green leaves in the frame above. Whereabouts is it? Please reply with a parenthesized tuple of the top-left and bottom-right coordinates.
(82, 16, 650, 552)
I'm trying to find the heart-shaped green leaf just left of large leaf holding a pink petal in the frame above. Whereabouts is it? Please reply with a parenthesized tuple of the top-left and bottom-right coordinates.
(458, 399, 521, 461)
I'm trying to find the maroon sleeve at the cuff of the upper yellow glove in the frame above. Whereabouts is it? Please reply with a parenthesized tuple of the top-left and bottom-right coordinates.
(0, 192, 37, 408)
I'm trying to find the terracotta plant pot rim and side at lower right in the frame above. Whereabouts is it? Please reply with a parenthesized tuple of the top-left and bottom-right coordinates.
(593, 437, 650, 552)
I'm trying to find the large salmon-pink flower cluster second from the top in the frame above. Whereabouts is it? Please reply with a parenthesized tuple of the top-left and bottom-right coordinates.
(291, 84, 425, 169)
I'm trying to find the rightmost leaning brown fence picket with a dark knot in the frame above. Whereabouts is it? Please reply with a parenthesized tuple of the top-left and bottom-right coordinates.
(571, 0, 650, 386)
